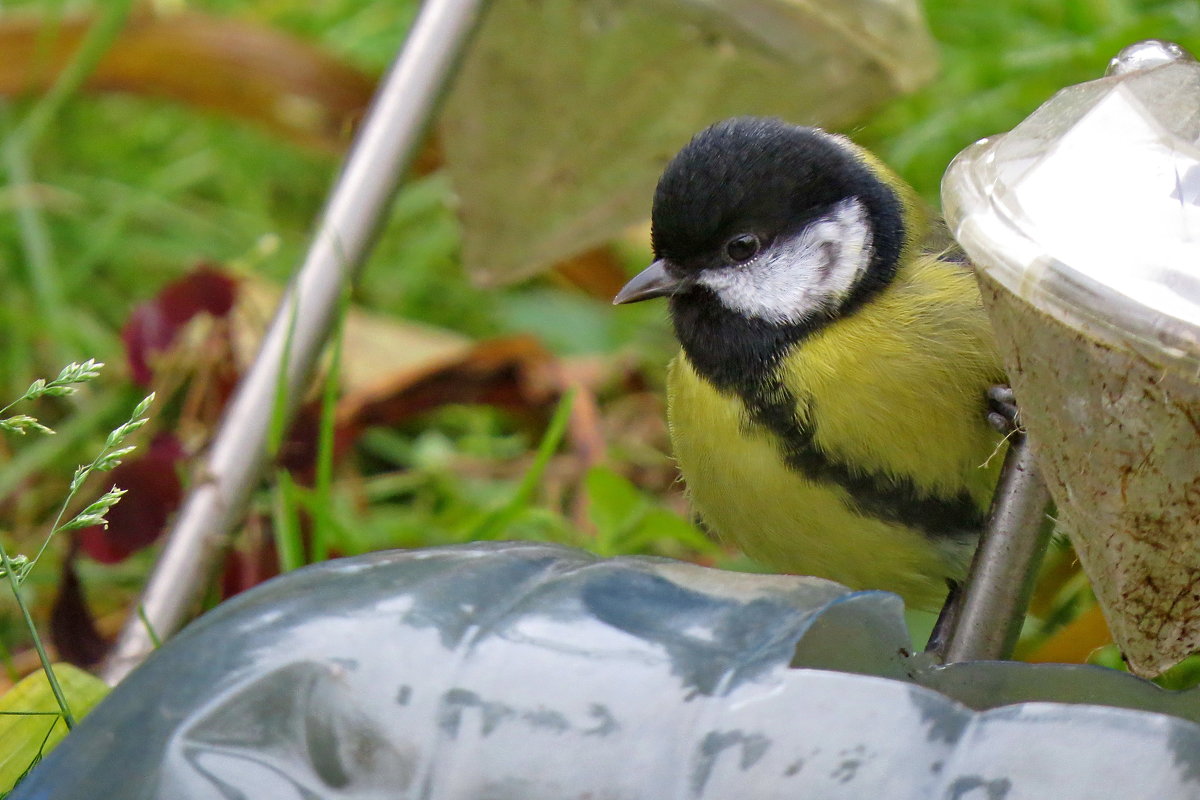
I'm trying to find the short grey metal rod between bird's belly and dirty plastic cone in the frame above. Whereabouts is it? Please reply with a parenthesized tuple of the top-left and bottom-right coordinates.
(934, 432, 1052, 663)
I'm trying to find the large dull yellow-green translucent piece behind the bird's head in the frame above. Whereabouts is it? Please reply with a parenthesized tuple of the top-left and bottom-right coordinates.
(439, 0, 936, 284)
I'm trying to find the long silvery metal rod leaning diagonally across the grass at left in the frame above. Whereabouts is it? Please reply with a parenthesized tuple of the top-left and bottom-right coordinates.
(103, 0, 485, 684)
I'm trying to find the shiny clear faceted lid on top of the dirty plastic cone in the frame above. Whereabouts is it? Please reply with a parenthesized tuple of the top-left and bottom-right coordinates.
(942, 41, 1200, 372)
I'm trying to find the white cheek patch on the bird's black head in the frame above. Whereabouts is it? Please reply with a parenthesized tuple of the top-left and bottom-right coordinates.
(697, 198, 871, 324)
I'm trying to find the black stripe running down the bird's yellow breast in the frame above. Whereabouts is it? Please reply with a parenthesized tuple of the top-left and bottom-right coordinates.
(742, 381, 986, 539)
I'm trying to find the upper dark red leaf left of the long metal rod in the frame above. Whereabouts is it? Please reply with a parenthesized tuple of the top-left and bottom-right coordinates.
(121, 264, 238, 386)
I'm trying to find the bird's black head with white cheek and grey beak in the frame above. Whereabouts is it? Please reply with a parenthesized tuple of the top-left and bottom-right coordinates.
(616, 118, 906, 393)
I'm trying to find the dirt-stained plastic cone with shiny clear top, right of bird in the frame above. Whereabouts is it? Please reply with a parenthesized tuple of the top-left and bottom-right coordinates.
(942, 41, 1200, 675)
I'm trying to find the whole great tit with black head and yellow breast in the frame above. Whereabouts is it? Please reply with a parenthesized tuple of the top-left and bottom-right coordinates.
(614, 118, 1004, 608)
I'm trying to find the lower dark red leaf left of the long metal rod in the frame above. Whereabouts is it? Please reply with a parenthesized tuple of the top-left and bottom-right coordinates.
(79, 433, 184, 564)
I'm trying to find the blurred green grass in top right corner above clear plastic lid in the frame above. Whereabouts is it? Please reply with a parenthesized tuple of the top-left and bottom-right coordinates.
(851, 0, 1200, 205)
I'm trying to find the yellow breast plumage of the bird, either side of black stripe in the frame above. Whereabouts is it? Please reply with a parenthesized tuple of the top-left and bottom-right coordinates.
(668, 253, 1002, 607)
